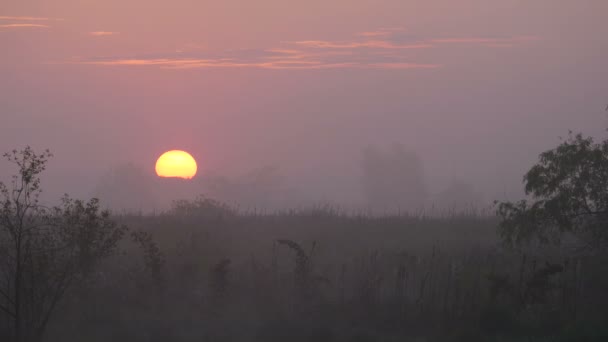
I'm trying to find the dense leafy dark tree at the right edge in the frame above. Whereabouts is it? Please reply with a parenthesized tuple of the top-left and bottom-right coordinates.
(497, 132, 608, 251)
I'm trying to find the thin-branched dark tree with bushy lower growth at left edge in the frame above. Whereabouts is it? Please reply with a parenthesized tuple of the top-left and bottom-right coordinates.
(0, 147, 126, 342)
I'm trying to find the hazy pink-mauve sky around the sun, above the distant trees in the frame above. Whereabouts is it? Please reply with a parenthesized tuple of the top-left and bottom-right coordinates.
(0, 0, 608, 208)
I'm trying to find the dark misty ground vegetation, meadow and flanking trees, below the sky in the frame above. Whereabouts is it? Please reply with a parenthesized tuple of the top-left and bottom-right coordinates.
(0, 140, 608, 342)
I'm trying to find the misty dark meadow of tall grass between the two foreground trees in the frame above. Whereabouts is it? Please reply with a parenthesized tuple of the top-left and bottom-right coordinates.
(40, 199, 608, 342)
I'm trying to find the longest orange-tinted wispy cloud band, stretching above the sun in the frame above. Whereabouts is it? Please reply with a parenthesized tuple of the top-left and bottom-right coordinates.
(70, 28, 538, 70)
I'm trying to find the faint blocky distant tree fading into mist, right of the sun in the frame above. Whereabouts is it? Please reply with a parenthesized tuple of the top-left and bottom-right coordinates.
(362, 144, 428, 210)
